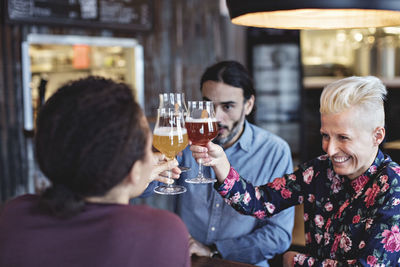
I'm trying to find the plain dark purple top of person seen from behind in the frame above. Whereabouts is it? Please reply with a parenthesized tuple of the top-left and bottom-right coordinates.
(0, 195, 190, 267)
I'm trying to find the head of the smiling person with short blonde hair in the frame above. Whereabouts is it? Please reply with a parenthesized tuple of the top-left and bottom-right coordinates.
(320, 77, 386, 179)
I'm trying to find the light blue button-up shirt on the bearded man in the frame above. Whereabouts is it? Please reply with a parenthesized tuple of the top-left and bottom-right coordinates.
(176, 121, 294, 266)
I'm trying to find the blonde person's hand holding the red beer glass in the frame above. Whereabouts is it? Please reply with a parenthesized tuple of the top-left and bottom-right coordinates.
(190, 142, 231, 183)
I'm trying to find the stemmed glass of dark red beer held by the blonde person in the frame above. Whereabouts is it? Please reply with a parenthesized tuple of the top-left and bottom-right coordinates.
(185, 101, 218, 184)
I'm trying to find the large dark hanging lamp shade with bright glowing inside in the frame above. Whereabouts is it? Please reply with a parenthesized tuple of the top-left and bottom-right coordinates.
(226, 0, 400, 29)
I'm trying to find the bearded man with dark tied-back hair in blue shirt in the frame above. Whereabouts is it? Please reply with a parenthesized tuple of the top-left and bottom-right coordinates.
(176, 61, 294, 266)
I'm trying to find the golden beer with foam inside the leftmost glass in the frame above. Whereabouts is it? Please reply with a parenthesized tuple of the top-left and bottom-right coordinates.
(153, 127, 189, 159)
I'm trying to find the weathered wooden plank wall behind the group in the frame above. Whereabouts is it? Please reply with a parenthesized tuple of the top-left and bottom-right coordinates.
(0, 0, 245, 203)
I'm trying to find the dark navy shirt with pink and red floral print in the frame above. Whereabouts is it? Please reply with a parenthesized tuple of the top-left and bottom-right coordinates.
(215, 151, 400, 267)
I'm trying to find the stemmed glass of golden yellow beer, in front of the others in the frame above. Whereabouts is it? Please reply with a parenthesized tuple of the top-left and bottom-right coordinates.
(153, 108, 188, 195)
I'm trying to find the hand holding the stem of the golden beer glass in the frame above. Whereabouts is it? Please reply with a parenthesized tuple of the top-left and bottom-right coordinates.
(150, 152, 181, 184)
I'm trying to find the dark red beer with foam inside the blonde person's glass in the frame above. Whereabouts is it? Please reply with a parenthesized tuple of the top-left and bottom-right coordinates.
(185, 118, 218, 146)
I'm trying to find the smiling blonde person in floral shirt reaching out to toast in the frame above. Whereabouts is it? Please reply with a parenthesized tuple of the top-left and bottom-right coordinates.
(191, 77, 400, 266)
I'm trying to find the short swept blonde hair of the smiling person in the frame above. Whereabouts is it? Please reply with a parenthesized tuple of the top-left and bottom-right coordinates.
(320, 76, 387, 127)
